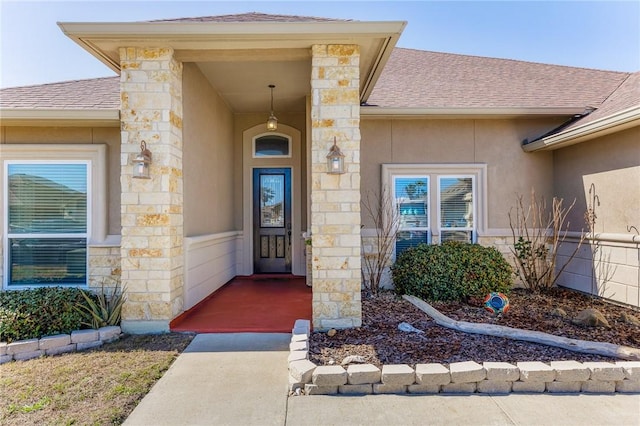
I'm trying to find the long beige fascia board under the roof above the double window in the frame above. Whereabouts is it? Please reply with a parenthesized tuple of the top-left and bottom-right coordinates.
(360, 105, 584, 118)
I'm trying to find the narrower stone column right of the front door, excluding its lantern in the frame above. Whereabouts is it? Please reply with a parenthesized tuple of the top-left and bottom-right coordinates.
(311, 45, 362, 330)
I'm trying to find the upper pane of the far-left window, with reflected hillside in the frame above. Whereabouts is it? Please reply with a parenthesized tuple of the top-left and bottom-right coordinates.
(8, 164, 87, 234)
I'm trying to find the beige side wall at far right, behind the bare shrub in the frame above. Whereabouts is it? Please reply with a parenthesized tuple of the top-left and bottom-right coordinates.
(554, 127, 640, 306)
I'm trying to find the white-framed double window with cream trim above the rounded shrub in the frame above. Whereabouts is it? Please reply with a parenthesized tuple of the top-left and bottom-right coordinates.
(383, 164, 486, 256)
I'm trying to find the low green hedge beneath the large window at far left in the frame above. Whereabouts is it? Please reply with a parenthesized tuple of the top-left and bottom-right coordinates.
(0, 287, 90, 342)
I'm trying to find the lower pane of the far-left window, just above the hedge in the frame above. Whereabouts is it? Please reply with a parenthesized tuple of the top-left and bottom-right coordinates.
(8, 238, 87, 286)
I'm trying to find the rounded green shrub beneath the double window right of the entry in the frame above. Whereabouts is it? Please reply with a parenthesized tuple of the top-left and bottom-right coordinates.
(391, 241, 513, 301)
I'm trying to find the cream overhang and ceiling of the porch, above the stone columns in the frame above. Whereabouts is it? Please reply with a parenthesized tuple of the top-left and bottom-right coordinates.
(58, 21, 406, 113)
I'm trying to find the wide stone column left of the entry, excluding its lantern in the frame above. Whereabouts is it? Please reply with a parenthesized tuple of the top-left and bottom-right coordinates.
(120, 48, 184, 333)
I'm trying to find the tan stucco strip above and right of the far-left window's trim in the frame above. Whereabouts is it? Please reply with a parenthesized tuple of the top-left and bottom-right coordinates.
(2, 126, 120, 235)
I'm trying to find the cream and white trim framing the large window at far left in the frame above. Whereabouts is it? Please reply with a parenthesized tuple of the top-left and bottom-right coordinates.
(0, 144, 107, 289)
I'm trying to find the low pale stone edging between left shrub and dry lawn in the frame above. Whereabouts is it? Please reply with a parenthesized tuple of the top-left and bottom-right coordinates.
(0, 326, 122, 364)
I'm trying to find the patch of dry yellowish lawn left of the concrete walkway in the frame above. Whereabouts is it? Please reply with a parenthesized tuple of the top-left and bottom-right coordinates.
(0, 333, 193, 425)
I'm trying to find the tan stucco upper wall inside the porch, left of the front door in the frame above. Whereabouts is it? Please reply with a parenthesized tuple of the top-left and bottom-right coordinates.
(183, 63, 235, 236)
